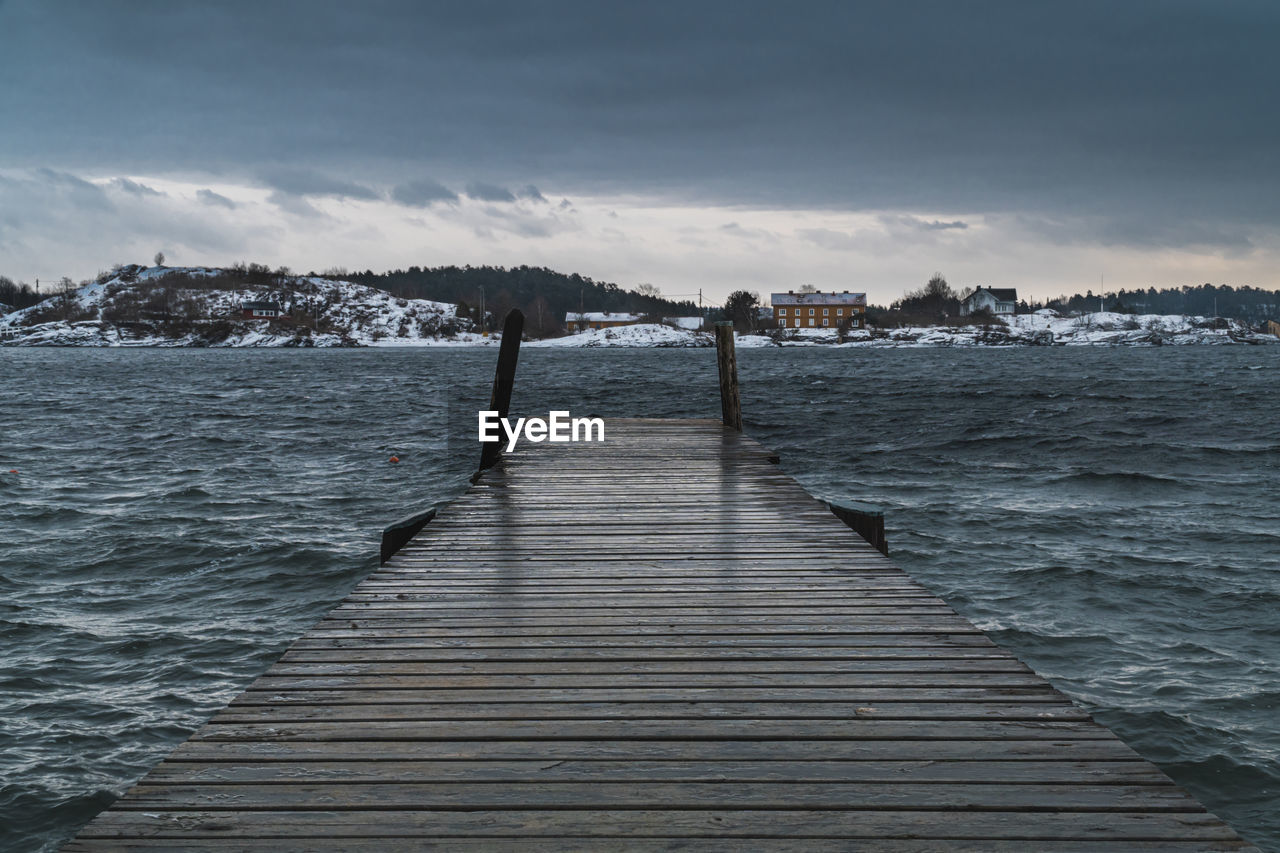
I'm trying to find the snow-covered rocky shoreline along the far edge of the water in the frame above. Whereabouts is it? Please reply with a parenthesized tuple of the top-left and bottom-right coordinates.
(0, 266, 1280, 348)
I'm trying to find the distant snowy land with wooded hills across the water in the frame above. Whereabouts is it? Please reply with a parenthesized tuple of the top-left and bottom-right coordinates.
(0, 264, 1280, 348)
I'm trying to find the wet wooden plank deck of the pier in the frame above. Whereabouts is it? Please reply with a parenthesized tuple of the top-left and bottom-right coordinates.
(64, 420, 1252, 850)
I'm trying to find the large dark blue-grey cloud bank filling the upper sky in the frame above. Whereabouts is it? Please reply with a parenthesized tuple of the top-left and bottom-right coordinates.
(0, 0, 1280, 237)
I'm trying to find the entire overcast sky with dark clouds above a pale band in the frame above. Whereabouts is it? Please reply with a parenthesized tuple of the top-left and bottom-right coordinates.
(0, 0, 1280, 302)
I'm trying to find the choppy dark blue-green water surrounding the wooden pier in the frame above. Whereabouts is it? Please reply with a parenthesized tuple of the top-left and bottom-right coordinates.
(0, 347, 1280, 850)
